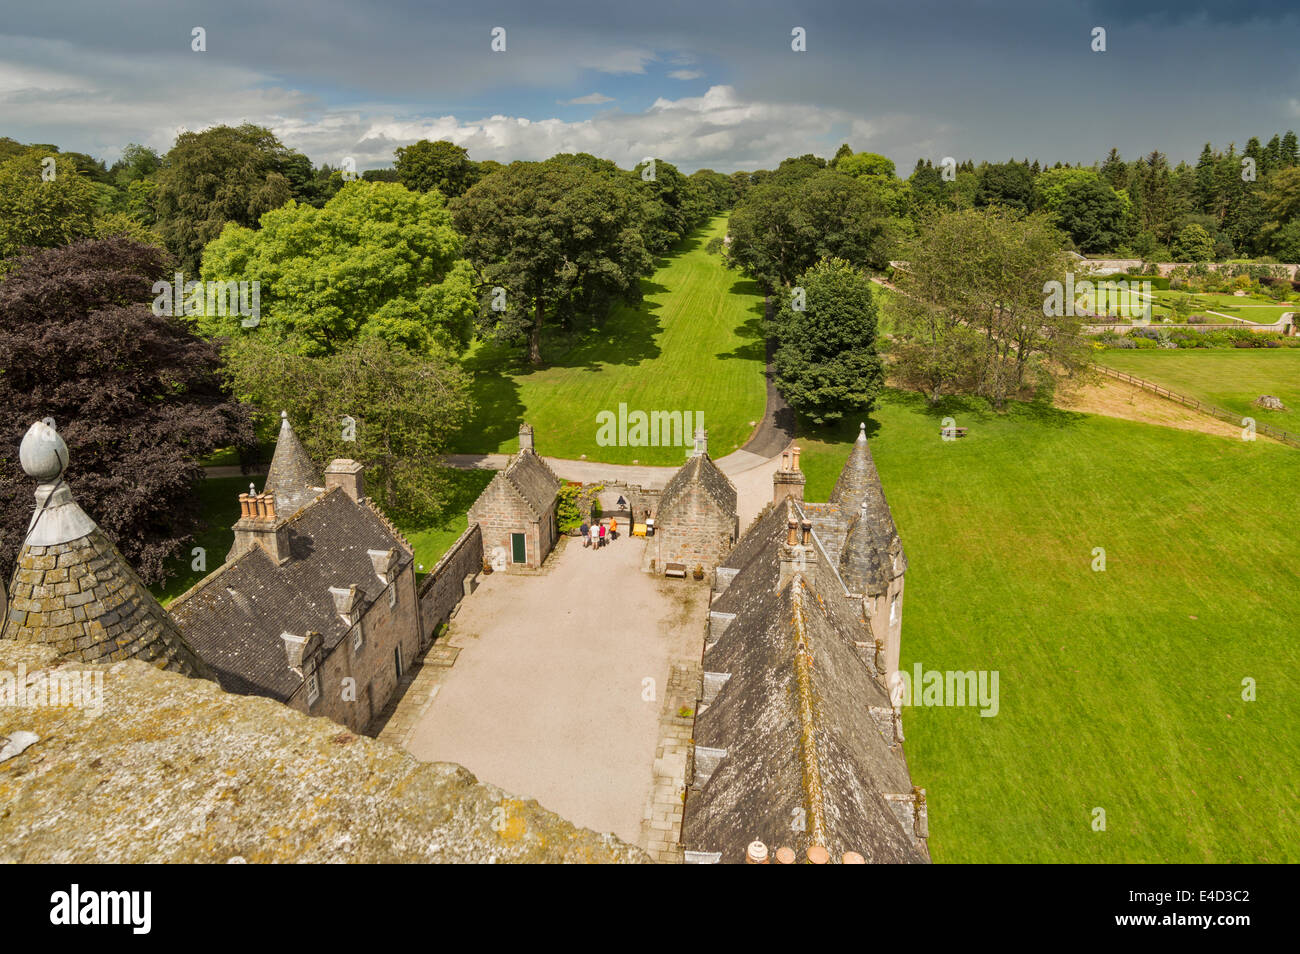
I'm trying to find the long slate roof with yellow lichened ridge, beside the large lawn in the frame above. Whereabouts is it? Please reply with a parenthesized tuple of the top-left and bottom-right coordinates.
(681, 447, 930, 863)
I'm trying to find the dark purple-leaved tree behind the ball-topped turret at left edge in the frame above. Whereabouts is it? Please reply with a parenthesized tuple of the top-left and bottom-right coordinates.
(0, 237, 252, 582)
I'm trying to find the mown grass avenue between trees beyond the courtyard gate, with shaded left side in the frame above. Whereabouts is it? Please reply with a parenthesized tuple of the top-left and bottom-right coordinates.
(454, 218, 766, 464)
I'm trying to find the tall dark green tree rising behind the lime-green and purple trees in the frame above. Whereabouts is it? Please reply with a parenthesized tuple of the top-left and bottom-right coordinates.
(155, 123, 293, 274)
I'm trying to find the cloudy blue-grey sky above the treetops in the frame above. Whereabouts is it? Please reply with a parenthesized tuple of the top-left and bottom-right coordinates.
(0, 0, 1300, 175)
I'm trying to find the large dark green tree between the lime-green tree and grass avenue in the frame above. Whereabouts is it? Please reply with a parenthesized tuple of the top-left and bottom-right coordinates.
(452, 160, 653, 365)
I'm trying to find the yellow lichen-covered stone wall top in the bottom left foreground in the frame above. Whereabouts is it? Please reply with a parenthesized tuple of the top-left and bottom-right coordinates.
(0, 639, 650, 863)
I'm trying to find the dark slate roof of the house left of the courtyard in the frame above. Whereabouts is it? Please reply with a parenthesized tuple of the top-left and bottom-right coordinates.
(172, 487, 413, 702)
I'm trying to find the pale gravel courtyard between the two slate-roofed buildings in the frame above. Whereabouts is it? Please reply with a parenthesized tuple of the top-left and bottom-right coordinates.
(407, 534, 709, 844)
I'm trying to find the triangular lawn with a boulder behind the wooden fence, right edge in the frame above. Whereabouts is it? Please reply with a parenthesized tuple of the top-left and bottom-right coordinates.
(1097, 348, 1300, 432)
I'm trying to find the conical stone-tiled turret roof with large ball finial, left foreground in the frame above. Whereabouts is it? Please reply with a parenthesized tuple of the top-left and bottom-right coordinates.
(4, 419, 208, 676)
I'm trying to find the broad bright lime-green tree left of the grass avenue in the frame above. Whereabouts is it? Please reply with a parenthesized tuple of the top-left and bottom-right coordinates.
(196, 182, 478, 355)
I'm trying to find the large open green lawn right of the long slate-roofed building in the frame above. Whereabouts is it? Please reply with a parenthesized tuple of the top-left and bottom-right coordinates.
(801, 392, 1300, 862)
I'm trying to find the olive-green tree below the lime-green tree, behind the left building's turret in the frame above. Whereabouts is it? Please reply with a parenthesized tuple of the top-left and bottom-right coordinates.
(228, 335, 473, 521)
